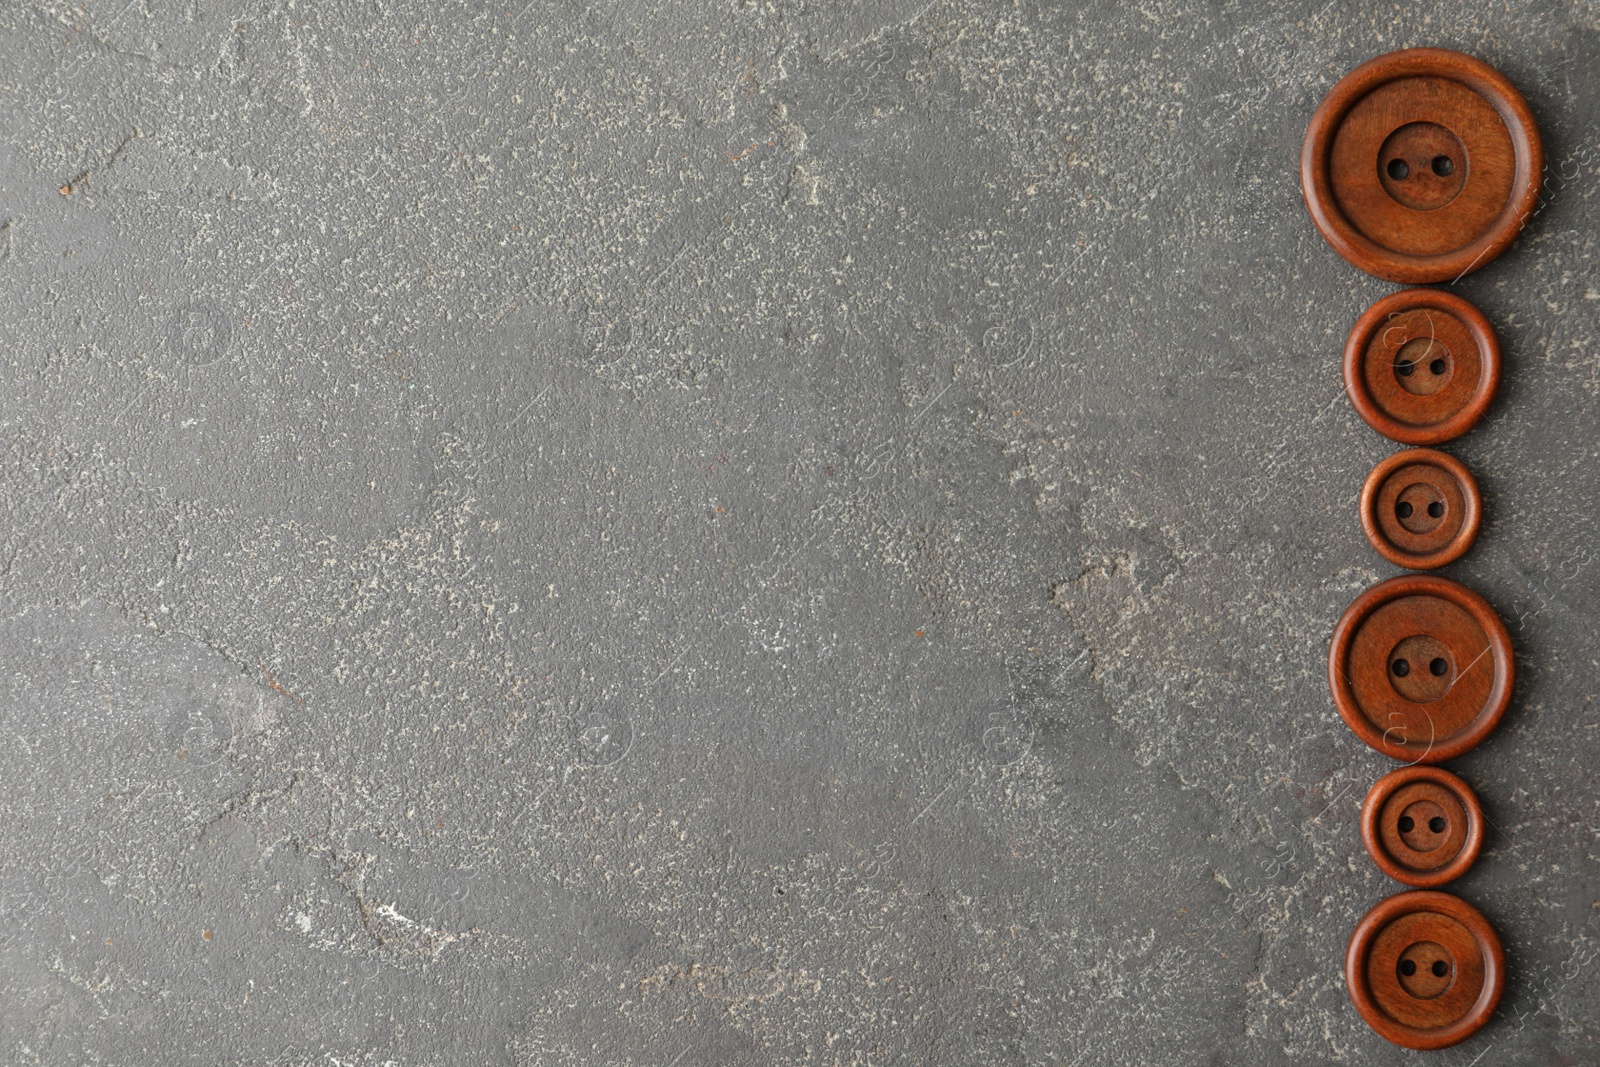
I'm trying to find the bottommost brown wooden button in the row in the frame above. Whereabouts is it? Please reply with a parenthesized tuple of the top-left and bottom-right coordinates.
(1344, 889, 1506, 1048)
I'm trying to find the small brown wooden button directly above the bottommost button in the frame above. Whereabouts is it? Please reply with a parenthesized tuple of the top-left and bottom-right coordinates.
(1362, 766, 1483, 889)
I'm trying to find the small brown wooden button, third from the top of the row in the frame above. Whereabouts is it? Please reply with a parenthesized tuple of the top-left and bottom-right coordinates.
(1362, 448, 1483, 571)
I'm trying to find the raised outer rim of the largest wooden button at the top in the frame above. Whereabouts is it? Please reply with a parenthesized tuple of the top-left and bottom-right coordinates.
(1301, 48, 1544, 285)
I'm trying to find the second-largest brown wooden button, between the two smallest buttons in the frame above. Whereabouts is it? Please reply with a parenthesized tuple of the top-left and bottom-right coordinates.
(1328, 574, 1517, 763)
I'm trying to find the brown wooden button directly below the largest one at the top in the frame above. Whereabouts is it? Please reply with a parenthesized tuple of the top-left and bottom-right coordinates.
(1344, 290, 1501, 445)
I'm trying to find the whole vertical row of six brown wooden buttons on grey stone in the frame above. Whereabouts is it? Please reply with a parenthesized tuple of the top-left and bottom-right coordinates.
(1301, 48, 1544, 1049)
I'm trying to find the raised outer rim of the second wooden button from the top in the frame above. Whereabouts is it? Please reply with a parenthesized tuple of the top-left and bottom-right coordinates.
(1344, 288, 1501, 445)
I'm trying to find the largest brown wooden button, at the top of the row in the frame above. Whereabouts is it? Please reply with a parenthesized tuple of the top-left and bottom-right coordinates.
(1301, 48, 1544, 285)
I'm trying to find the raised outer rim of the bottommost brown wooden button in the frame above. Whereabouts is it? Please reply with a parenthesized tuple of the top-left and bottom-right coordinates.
(1344, 889, 1506, 1049)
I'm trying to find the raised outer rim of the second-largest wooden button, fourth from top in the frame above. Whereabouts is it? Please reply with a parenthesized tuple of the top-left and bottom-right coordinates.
(1328, 574, 1517, 763)
